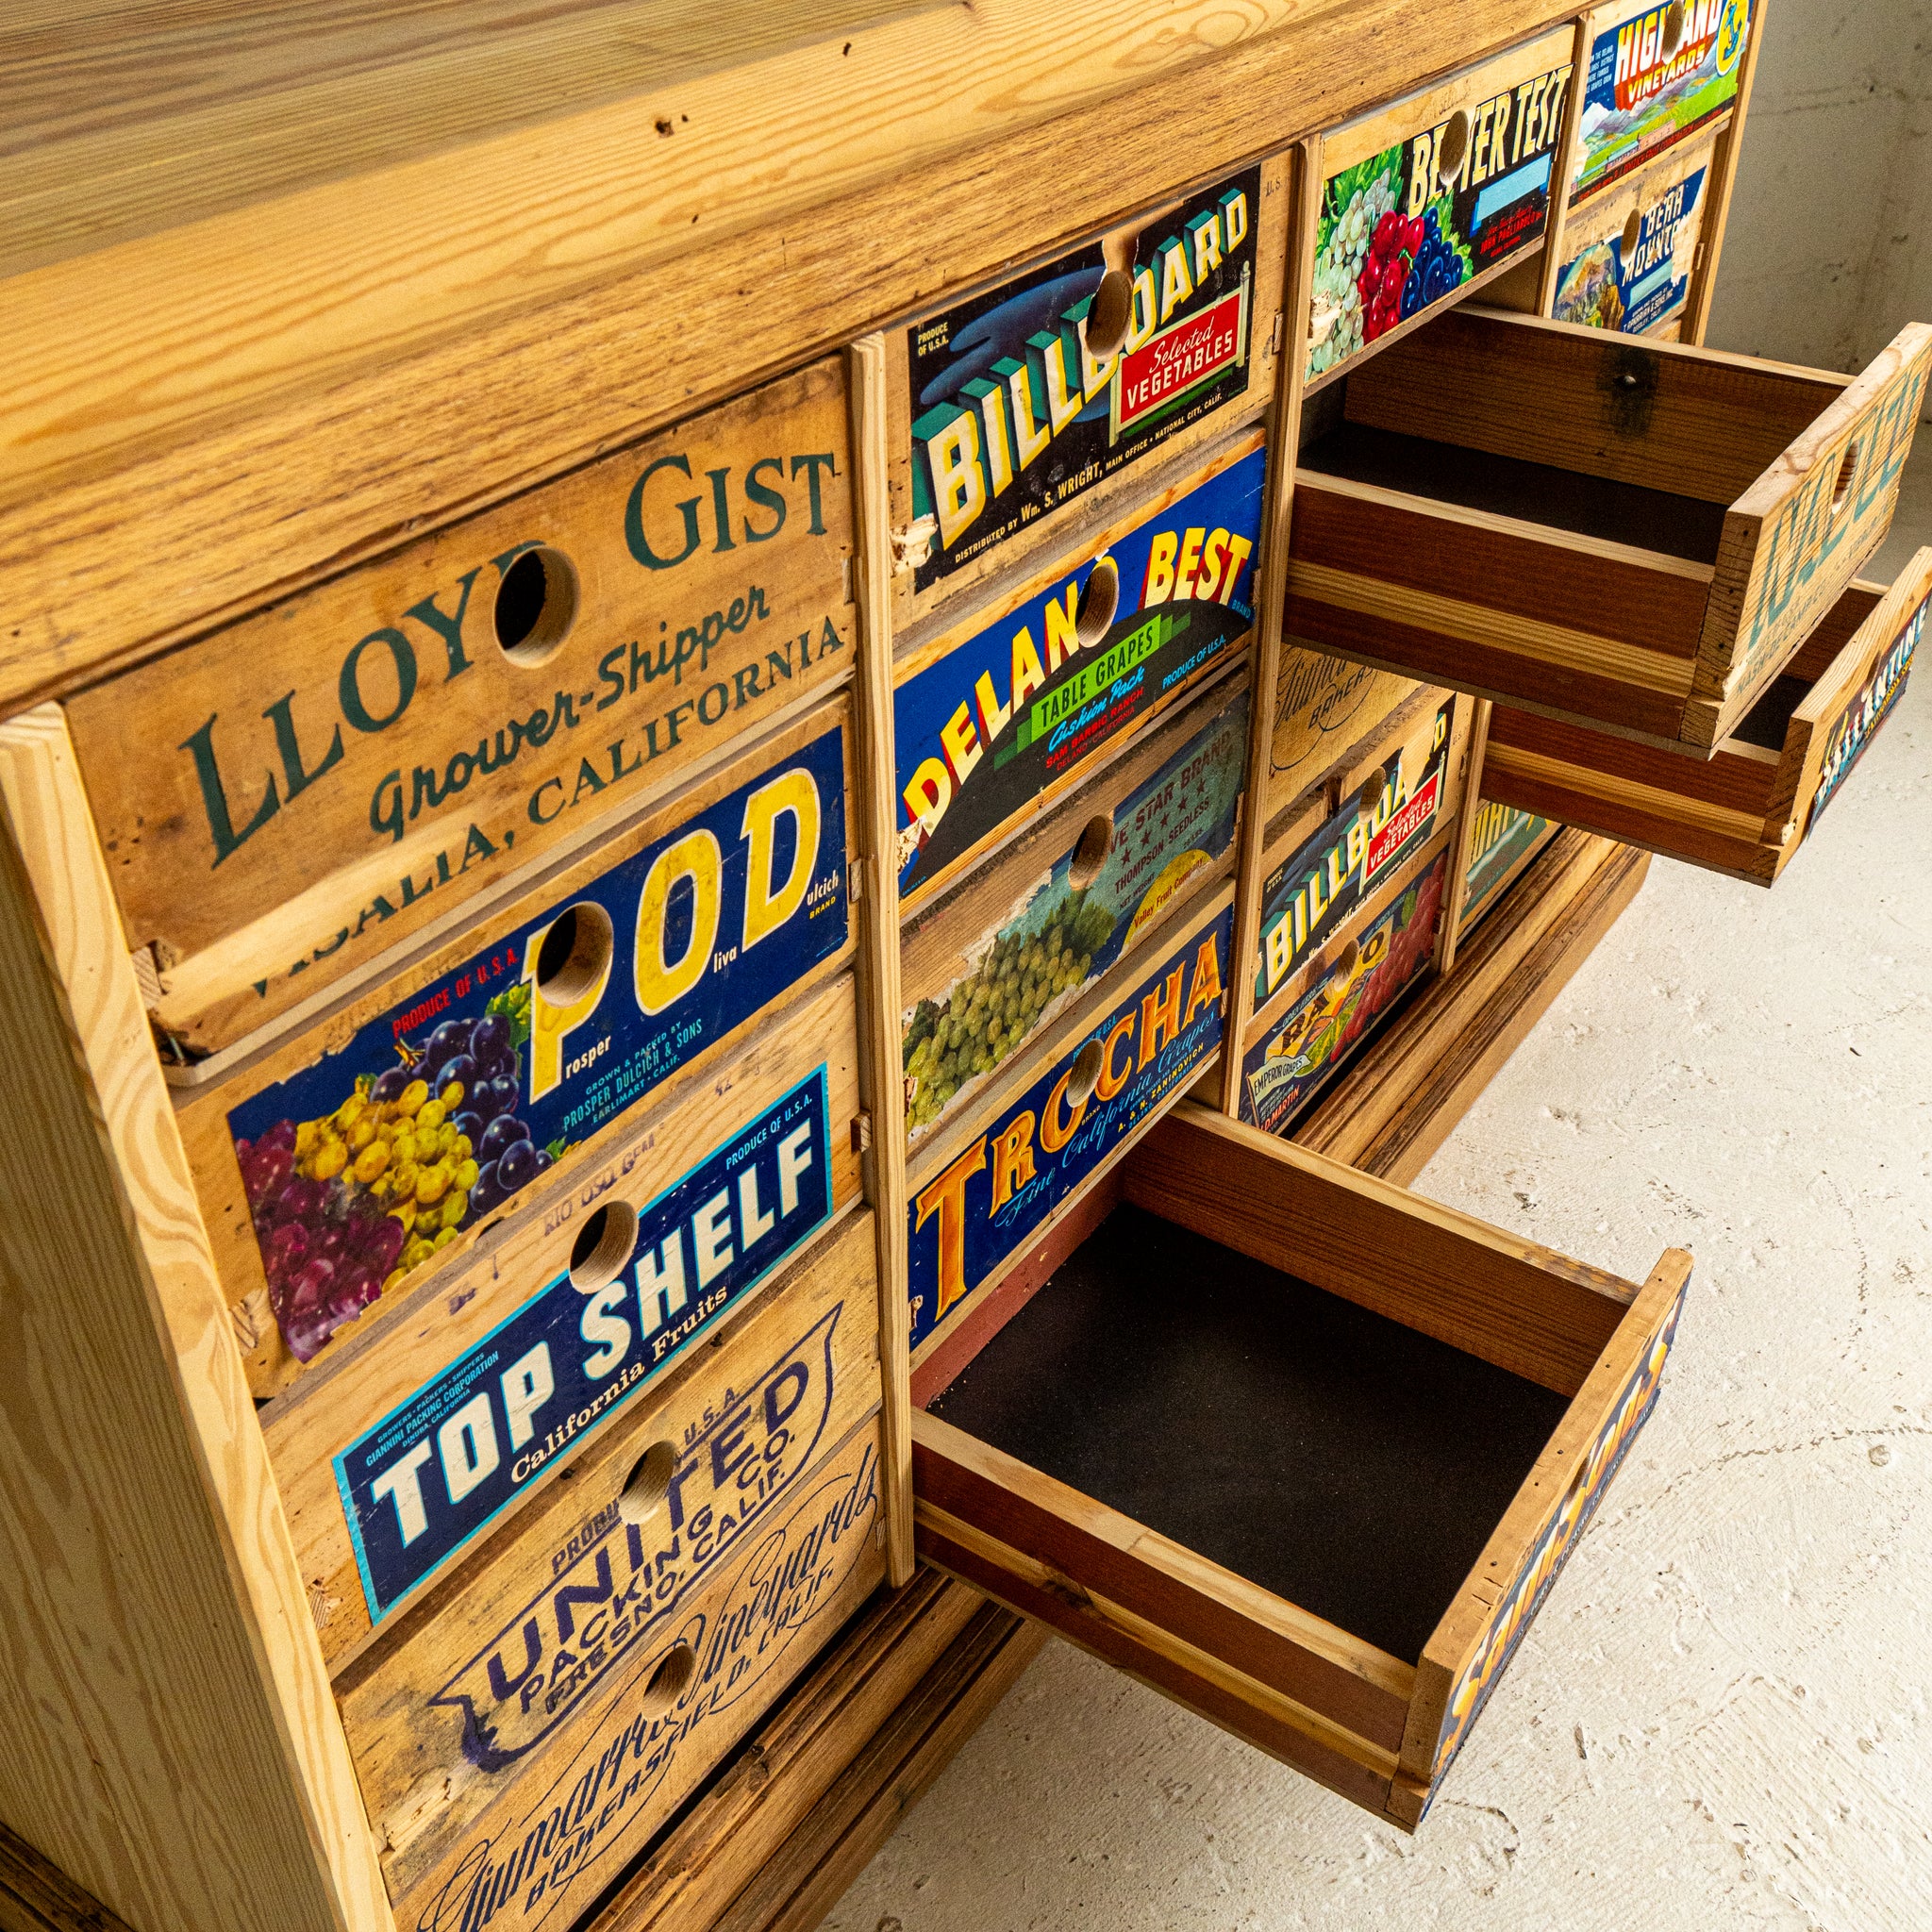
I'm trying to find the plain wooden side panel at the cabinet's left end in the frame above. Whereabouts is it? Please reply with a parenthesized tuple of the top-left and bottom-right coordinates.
(0, 708, 391, 1932)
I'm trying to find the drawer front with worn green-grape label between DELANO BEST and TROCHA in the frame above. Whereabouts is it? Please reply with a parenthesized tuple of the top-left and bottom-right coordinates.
(900, 676, 1248, 1145)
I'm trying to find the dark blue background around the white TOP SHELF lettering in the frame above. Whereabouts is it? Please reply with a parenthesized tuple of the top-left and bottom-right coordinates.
(334, 1066, 833, 1623)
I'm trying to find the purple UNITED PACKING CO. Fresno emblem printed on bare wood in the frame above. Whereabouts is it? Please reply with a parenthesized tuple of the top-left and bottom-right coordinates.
(427, 1307, 854, 1772)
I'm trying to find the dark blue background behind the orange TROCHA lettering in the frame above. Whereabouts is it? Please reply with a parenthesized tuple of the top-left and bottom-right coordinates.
(907, 908, 1235, 1342)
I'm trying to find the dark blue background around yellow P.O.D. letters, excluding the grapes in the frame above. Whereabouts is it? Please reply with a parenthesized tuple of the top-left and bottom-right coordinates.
(228, 728, 846, 1224)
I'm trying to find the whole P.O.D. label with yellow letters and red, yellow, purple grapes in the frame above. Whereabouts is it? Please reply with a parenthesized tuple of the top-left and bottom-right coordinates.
(228, 728, 848, 1362)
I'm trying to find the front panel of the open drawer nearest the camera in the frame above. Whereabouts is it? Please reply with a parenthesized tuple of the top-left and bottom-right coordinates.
(1391, 1248, 1690, 1825)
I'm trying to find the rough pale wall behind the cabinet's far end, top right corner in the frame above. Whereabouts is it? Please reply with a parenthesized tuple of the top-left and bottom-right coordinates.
(1707, 0, 1932, 388)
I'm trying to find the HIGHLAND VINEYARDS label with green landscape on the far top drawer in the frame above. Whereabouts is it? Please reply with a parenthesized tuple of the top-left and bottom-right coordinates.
(1571, 0, 1755, 197)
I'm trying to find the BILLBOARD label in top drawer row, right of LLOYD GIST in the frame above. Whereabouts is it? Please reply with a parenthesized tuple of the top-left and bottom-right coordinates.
(907, 166, 1261, 591)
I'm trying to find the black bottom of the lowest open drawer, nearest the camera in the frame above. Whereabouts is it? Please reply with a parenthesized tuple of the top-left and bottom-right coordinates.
(929, 1204, 1569, 1663)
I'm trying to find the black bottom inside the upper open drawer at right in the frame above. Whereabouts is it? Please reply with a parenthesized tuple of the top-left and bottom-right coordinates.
(1300, 417, 1725, 564)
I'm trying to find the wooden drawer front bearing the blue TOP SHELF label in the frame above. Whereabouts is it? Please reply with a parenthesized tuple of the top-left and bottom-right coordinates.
(263, 975, 859, 1659)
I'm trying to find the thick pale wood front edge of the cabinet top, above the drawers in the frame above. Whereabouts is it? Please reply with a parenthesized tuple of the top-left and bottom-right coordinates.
(0, 0, 1584, 708)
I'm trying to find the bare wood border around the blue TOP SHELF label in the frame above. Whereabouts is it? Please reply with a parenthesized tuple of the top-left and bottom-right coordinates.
(263, 975, 859, 1669)
